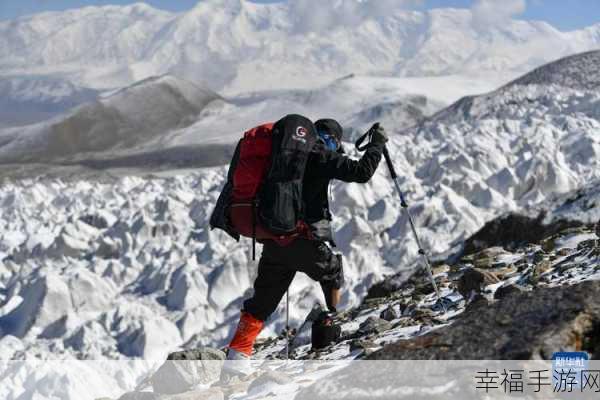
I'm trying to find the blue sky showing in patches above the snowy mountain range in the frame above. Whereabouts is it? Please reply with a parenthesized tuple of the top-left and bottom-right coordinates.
(0, 0, 600, 30)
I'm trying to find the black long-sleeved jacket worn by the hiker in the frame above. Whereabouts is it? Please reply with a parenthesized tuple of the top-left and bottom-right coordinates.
(302, 143, 383, 242)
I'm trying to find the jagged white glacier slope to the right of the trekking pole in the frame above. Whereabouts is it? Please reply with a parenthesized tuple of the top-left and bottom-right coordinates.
(382, 49, 600, 256)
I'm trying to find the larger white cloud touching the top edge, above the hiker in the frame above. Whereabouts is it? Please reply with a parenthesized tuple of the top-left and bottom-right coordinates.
(288, 0, 423, 33)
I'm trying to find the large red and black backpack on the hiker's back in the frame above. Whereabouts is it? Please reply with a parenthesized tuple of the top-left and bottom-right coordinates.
(210, 115, 317, 256)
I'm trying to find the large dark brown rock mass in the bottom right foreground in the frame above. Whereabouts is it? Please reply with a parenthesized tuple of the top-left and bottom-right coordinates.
(367, 281, 600, 360)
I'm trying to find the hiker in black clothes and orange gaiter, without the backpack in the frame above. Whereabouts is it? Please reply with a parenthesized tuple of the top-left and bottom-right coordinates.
(227, 119, 388, 360)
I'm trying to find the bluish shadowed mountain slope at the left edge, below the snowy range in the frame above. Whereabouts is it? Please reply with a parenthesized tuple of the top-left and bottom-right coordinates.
(0, 76, 98, 128)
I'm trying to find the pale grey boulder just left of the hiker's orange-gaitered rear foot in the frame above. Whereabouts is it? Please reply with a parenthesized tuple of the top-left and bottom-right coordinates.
(152, 348, 225, 394)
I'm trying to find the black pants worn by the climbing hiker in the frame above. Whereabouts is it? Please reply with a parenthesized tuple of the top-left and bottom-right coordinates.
(244, 239, 344, 321)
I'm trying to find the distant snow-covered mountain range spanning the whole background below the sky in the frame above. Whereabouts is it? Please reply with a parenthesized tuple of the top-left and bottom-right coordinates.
(0, 0, 600, 92)
